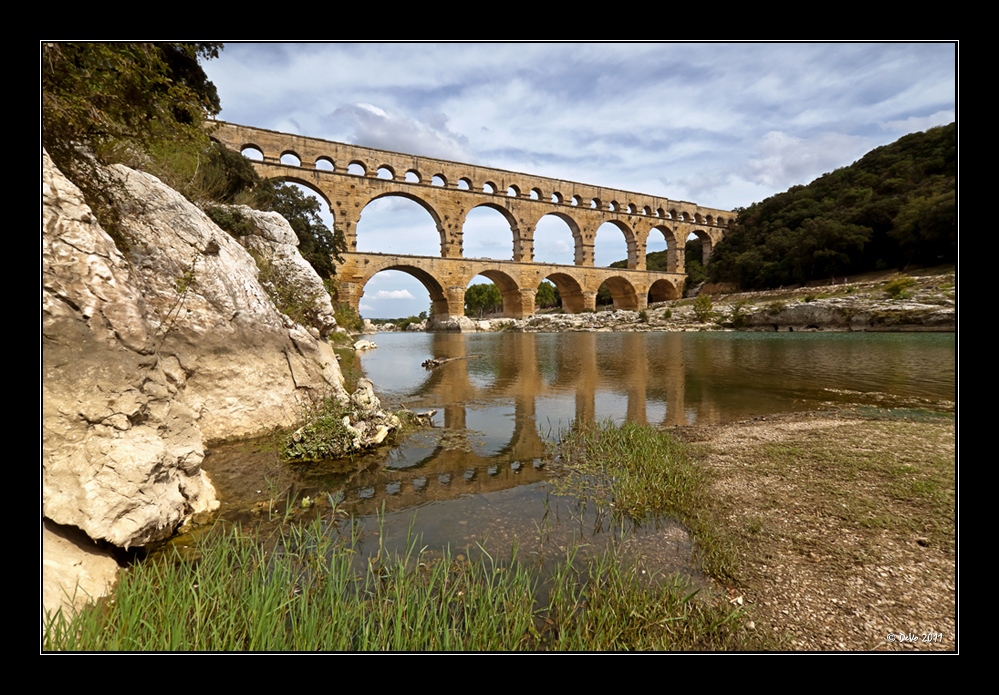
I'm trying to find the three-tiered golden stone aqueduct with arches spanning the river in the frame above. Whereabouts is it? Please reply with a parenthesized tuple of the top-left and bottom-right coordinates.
(211, 122, 734, 320)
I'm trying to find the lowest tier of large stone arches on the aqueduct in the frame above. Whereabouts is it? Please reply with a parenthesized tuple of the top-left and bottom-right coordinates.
(337, 253, 686, 319)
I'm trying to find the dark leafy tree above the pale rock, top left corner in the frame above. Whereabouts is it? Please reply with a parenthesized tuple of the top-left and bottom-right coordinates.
(41, 43, 222, 246)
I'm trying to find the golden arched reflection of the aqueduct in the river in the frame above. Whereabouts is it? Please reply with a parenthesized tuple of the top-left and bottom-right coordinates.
(334, 333, 704, 511)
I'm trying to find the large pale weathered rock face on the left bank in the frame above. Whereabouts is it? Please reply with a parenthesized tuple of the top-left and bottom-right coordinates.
(42, 154, 345, 547)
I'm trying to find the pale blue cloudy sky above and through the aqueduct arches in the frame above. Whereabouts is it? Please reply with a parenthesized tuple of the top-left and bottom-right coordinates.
(204, 43, 957, 318)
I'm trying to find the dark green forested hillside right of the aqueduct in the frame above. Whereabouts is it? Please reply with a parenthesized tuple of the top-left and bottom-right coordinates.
(707, 123, 957, 289)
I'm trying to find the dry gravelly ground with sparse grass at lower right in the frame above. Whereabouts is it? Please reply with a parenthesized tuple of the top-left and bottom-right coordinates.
(677, 411, 957, 651)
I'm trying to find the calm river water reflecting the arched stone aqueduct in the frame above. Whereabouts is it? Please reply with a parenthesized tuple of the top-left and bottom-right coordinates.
(204, 332, 956, 571)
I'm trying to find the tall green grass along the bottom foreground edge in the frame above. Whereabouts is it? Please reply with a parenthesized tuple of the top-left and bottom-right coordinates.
(43, 519, 766, 651)
